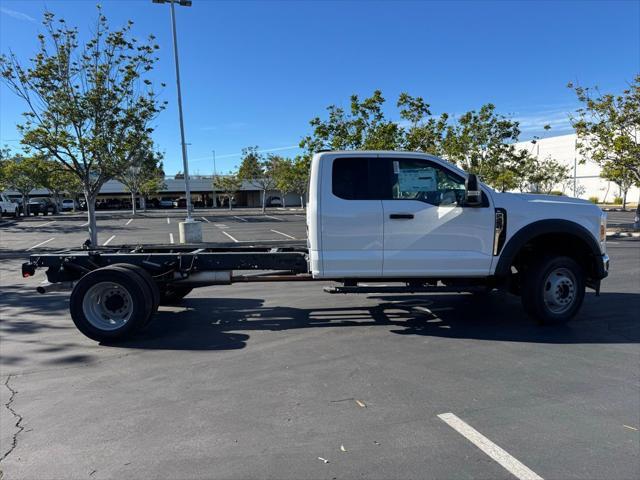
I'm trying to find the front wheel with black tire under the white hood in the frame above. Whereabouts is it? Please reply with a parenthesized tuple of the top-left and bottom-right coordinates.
(521, 256, 585, 324)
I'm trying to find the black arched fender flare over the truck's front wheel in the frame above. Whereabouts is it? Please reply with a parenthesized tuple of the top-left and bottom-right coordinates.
(495, 219, 607, 279)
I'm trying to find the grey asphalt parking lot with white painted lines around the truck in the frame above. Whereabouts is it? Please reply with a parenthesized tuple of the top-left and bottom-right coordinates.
(0, 210, 640, 479)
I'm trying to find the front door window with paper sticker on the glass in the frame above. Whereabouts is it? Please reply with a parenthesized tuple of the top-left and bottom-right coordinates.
(391, 159, 464, 206)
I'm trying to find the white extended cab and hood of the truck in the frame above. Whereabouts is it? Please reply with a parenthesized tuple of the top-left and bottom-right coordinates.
(307, 151, 608, 322)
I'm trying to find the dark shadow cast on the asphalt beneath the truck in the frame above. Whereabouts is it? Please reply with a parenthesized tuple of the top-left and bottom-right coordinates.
(117, 293, 640, 350)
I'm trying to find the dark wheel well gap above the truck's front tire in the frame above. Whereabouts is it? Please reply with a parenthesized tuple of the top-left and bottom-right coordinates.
(510, 233, 595, 277)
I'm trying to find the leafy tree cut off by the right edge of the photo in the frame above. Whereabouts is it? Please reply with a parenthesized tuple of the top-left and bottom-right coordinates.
(568, 74, 640, 229)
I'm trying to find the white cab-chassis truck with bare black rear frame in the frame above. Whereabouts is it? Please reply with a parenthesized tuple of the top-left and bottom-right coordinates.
(22, 151, 609, 341)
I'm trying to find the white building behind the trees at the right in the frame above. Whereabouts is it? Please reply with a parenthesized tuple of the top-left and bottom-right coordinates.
(516, 133, 639, 203)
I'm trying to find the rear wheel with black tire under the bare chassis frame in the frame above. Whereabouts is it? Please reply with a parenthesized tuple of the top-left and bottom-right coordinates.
(69, 267, 152, 342)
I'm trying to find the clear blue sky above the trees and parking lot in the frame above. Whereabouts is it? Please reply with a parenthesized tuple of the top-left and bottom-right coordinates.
(0, 0, 640, 174)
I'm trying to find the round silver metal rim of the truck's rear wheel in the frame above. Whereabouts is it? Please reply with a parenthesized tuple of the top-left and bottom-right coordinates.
(82, 282, 133, 330)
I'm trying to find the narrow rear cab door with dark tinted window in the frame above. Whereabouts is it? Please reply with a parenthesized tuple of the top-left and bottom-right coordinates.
(320, 155, 384, 278)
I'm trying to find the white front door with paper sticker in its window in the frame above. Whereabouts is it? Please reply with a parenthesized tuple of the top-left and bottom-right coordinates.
(380, 157, 495, 277)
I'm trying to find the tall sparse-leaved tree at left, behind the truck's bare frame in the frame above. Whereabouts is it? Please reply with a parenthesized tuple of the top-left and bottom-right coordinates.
(0, 6, 164, 245)
